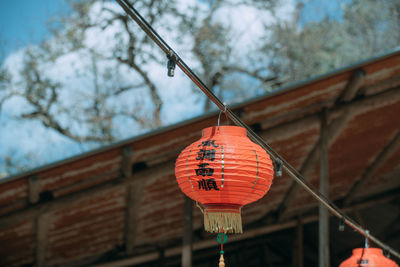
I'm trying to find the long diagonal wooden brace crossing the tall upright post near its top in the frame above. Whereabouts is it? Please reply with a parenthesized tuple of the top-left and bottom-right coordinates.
(276, 71, 363, 221)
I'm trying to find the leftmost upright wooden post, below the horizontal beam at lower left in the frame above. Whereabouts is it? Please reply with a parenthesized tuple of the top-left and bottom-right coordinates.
(36, 213, 49, 267)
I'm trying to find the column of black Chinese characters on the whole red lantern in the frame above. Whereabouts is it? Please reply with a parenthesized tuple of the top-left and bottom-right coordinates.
(195, 140, 219, 191)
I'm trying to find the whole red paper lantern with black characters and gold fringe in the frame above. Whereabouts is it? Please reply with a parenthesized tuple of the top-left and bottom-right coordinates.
(175, 126, 274, 233)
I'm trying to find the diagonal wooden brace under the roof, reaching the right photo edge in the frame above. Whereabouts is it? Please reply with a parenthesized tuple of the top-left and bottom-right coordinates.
(343, 130, 400, 206)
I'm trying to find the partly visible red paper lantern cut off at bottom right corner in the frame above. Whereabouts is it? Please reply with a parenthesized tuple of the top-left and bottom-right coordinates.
(339, 248, 398, 267)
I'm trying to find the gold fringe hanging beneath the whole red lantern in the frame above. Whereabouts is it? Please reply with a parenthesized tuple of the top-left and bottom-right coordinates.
(204, 210, 243, 234)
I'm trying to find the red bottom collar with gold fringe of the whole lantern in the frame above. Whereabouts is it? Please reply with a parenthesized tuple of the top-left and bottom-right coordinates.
(204, 205, 243, 234)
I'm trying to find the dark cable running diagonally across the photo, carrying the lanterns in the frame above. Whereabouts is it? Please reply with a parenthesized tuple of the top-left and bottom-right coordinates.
(116, 0, 400, 259)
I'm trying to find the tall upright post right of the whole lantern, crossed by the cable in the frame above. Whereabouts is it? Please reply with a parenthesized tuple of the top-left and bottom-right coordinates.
(318, 109, 330, 267)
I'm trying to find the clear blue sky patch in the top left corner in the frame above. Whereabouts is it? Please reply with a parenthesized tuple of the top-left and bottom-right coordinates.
(0, 0, 68, 57)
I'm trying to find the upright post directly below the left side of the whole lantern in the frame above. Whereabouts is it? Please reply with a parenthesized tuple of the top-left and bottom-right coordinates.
(182, 196, 193, 267)
